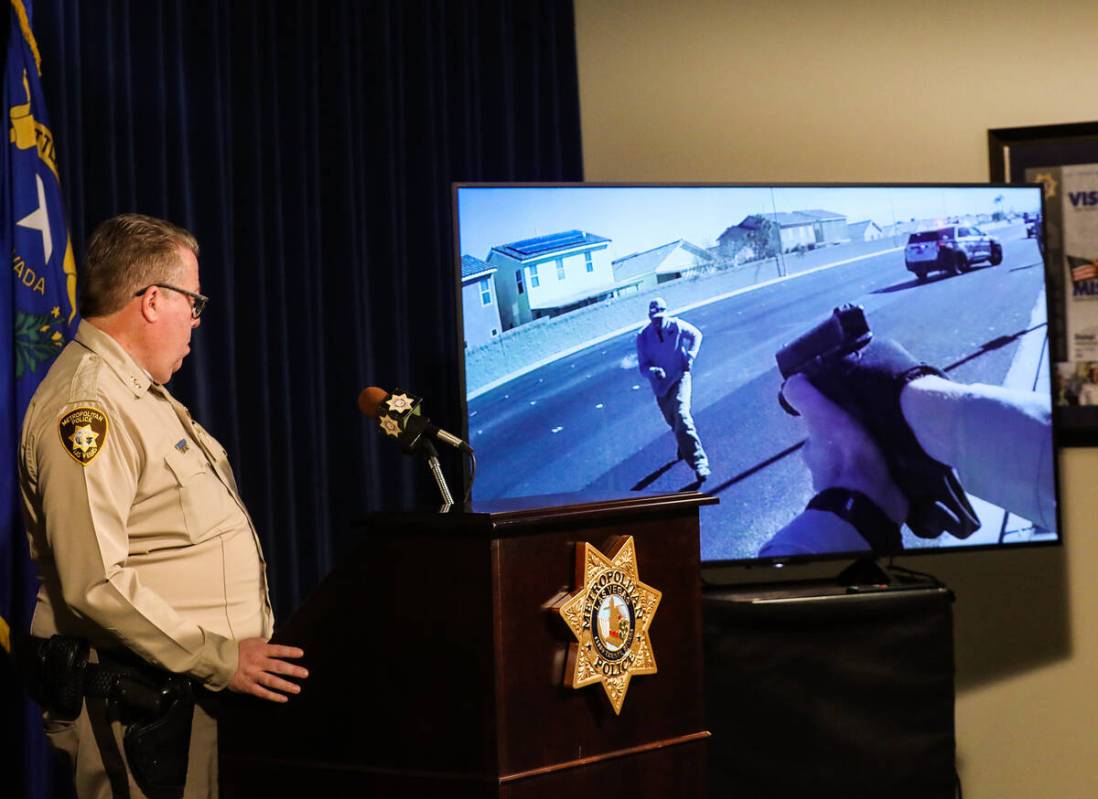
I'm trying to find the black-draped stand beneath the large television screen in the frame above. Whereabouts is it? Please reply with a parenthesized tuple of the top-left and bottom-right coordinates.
(703, 579, 955, 799)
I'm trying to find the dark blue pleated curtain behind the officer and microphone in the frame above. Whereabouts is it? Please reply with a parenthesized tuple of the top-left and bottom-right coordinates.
(9, 0, 582, 796)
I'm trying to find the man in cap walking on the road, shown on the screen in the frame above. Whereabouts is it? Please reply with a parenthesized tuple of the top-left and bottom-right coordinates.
(637, 296, 709, 484)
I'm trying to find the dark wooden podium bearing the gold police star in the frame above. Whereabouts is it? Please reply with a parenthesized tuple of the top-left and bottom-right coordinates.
(221, 493, 716, 799)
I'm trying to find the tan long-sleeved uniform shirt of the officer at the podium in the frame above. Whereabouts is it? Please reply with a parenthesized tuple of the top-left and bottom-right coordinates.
(20, 322, 272, 688)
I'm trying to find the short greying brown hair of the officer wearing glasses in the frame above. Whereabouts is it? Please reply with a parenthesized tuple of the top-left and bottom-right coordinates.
(79, 214, 199, 316)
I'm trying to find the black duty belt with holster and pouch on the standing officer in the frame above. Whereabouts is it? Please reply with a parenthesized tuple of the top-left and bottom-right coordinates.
(19, 635, 194, 799)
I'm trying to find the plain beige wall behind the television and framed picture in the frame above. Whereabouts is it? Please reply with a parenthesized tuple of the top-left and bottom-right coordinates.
(575, 0, 1098, 799)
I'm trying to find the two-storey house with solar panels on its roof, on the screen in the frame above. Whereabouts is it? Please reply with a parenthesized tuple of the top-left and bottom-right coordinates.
(486, 230, 614, 330)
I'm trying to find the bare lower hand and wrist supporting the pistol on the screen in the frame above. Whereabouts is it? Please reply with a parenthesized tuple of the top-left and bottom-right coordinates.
(782, 374, 908, 524)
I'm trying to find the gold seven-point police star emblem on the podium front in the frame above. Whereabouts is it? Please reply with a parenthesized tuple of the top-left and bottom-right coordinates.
(557, 536, 663, 714)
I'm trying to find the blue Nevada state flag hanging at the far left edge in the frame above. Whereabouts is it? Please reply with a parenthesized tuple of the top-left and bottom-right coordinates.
(0, 0, 78, 796)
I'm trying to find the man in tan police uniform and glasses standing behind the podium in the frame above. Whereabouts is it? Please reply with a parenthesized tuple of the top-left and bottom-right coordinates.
(20, 214, 307, 799)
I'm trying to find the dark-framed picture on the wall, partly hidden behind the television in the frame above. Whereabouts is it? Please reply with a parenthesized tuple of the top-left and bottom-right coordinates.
(987, 122, 1098, 447)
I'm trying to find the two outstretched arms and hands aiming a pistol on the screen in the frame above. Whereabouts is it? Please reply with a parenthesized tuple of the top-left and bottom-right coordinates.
(760, 306, 1056, 558)
